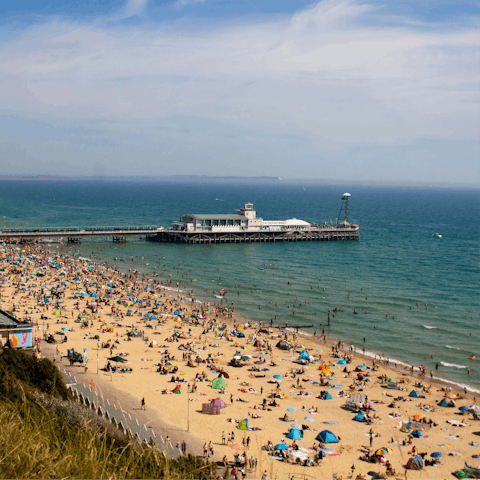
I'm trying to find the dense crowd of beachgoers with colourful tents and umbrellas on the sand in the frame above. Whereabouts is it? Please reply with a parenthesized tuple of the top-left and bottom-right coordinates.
(0, 245, 478, 476)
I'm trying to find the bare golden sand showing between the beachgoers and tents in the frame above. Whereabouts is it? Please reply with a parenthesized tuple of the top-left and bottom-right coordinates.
(1, 246, 480, 479)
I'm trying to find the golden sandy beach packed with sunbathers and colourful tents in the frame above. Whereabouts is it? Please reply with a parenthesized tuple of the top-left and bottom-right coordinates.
(0, 246, 480, 479)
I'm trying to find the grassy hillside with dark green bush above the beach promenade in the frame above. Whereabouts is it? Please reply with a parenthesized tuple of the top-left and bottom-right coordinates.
(0, 349, 216, 480)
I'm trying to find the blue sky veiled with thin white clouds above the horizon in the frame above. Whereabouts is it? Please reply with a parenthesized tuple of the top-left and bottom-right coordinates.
(0, 0, 480, 184)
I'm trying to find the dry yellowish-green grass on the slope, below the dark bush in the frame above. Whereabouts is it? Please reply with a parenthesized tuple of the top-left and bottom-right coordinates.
(0, 399, 215, 480)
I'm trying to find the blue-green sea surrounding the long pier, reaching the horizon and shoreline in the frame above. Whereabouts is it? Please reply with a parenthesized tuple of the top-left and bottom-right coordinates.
(0, 179, 480, 393)
